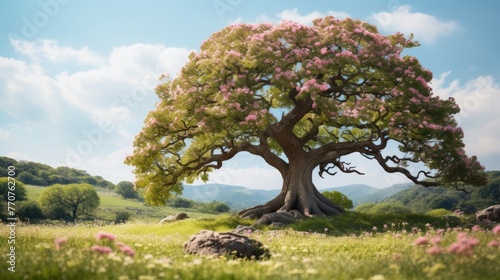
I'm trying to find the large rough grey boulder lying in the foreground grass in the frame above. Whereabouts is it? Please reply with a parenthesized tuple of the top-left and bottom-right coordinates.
(184, 230, 269, 259)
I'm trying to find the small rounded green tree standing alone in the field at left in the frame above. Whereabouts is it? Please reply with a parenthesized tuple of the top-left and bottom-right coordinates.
(40, 184, 100, 222)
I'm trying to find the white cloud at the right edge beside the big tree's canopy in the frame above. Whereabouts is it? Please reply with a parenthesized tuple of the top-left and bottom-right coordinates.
(431, 72, 500, 170)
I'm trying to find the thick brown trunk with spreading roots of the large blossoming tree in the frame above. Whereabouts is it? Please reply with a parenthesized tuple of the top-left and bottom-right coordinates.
(238, 160, 344, 218)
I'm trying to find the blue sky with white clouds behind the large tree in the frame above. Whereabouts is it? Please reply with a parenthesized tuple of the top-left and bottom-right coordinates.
(0, 0, 500, 189)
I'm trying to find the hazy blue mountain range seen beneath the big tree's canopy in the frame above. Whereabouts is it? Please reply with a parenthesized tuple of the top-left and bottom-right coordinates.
(181, 183, 413, 210)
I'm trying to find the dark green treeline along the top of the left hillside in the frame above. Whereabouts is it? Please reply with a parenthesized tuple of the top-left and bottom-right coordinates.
(0, 157, 115, 189)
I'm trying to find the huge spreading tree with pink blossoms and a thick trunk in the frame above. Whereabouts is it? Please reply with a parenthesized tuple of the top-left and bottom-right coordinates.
(125, 17, 486, 217)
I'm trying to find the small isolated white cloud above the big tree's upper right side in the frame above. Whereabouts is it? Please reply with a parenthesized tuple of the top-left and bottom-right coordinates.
(372, 5, 460, 44)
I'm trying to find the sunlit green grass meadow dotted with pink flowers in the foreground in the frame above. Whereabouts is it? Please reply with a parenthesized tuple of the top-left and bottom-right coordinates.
(0, 213, 500, 280)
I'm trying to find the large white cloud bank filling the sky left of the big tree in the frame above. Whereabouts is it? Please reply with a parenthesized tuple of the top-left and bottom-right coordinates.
(0, 40, 190, 181)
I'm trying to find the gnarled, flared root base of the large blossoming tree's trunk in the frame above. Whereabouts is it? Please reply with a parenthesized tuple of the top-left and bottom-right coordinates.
(238, 188, 344, 224)
